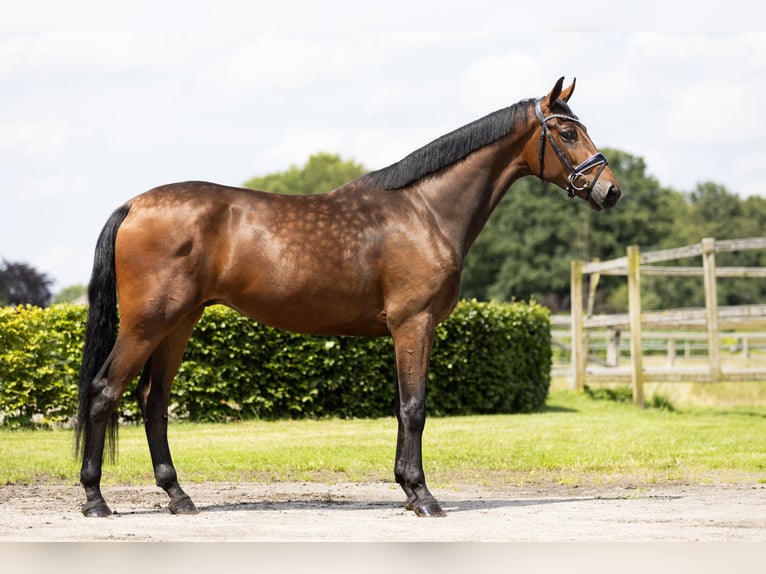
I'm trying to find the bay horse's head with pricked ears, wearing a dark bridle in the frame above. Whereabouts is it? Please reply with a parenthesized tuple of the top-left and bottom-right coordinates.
(525, 78, 622, 211)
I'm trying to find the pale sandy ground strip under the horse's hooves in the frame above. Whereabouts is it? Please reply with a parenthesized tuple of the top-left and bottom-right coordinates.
(0, 482, 766, 542)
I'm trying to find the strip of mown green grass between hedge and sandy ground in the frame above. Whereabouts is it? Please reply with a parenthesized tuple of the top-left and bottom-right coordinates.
(0, 391, 766, 486)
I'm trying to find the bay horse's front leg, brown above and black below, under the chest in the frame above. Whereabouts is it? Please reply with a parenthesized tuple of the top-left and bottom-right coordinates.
(392, 314, 446, 516)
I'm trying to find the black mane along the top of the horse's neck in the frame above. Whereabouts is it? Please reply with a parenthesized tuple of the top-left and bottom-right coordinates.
(362, 100, 530, 189)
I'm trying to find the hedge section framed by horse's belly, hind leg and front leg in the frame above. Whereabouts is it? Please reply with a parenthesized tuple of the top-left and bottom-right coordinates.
(176, 306, 402, 421)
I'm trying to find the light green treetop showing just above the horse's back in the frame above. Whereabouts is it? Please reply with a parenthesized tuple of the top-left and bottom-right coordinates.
(245, 152, 369, 195)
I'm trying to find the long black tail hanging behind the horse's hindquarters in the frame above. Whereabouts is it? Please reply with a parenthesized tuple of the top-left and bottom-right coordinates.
(75, 204, 130, 466)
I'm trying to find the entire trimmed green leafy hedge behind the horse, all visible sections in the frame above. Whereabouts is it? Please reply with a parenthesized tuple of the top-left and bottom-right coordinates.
(0, 301, 551, 427)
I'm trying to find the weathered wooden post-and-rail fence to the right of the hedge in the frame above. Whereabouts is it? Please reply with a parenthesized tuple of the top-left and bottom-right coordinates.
(571, 237, 766, 406)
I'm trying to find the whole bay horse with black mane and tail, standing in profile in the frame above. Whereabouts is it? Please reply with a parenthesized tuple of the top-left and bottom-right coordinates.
(76, 74, 621, 516)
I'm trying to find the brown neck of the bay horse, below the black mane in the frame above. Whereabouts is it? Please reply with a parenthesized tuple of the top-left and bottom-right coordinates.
(417, 136, 530, 258)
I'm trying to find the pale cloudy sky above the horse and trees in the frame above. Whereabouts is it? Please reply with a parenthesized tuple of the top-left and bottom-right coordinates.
(0, 0, 766, 292)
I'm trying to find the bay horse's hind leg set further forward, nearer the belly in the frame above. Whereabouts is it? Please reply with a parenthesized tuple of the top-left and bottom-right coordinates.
(137, 308, 203, 514)
